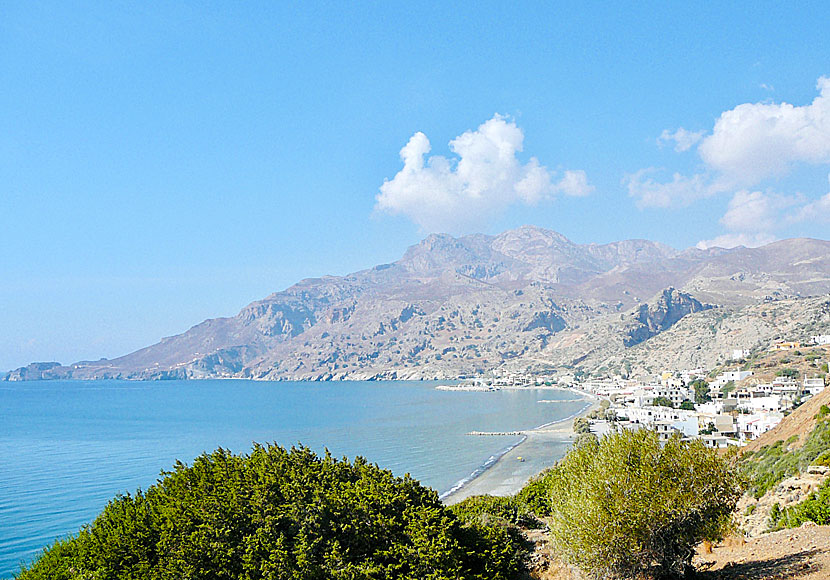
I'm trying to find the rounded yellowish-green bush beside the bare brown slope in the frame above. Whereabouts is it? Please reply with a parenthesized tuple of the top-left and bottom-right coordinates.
(545, 430, 743, 578)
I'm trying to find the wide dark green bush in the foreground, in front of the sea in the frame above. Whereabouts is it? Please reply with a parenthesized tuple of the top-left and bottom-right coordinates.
(18, 446, 522, 580)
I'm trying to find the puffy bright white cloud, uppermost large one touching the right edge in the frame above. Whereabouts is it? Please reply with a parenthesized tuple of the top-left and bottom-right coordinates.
(698, 77, 830, 186)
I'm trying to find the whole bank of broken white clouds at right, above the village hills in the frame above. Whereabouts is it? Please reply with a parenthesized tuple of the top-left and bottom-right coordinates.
(636, 77, 830, 248)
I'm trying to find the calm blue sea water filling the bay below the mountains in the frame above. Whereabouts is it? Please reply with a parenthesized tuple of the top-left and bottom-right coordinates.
(0, 380, 584, 578)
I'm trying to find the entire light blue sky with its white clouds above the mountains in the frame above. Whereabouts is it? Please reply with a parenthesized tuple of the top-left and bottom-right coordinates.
(0, 1, 830, 369)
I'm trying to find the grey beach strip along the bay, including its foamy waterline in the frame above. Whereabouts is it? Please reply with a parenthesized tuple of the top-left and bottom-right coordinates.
(439, 389, 600, 505)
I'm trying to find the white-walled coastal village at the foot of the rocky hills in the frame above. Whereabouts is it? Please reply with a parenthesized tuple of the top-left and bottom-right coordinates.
(456, 335, 830, 449)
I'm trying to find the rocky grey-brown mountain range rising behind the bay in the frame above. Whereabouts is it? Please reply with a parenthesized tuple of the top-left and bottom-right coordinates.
(2, 226, 830, 380)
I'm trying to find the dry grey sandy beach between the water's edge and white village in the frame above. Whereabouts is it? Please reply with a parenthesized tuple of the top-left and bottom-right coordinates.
(442, 393, 600, 505)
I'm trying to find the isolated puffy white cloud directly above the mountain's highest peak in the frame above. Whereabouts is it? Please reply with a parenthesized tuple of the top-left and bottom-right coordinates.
(375, 115, 593, 233)
